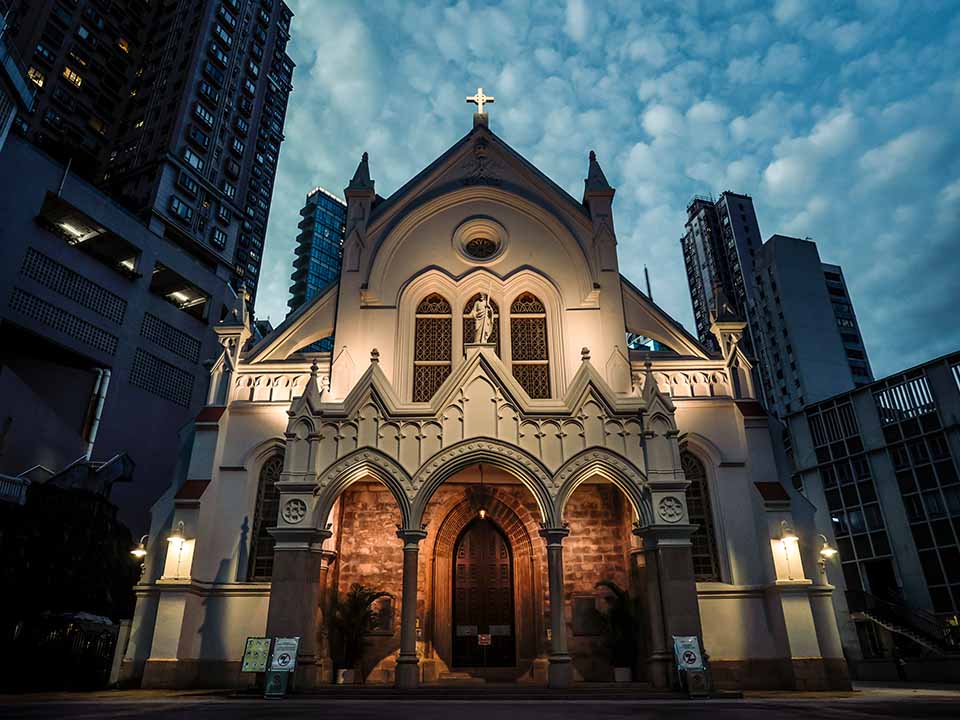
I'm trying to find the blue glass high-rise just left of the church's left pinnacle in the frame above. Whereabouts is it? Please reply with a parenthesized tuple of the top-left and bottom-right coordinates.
(287, 187, 347, 318)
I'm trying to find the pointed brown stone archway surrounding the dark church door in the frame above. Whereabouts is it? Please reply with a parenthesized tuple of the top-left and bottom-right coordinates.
(425, 488, 546, 679)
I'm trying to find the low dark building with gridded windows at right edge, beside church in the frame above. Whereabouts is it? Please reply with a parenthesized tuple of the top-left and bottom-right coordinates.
(787, 353, 960, 676)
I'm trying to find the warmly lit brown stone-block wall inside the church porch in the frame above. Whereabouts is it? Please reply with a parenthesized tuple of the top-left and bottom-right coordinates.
(331, 482, 630, 682)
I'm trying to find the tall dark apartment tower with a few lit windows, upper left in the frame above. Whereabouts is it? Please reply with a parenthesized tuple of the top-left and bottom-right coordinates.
(8, 0, 294, 304)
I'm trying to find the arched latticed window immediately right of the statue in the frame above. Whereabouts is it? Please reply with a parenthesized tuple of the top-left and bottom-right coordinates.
(510, 292, 550, 398)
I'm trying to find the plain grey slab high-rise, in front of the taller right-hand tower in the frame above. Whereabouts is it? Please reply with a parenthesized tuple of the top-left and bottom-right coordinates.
(751, 235, 873, 418)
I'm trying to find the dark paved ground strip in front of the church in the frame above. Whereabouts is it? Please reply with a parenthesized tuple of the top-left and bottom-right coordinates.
(0, 687, 960, 720)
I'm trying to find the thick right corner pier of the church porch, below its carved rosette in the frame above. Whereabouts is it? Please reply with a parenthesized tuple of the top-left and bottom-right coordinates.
(634, 524, 706, 687)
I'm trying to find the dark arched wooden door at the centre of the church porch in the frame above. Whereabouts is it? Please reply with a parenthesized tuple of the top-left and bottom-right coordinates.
(453, 517, 516, 668)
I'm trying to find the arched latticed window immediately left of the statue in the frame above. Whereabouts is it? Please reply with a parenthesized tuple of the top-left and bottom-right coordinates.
(413, 293, 453, 402)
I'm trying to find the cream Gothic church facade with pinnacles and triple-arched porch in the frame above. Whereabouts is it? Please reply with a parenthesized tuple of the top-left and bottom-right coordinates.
(118, 108, 849, 689)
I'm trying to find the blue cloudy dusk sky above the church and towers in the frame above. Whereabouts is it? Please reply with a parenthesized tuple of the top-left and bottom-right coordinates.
(257, 0, 960, 377)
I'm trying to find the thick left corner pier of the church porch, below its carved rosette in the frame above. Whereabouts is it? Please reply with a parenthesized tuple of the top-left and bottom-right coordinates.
(267, 528, 330, 688)
